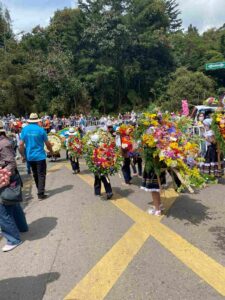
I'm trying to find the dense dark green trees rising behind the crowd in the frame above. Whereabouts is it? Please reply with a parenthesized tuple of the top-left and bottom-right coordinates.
(0, 0, 225, 115)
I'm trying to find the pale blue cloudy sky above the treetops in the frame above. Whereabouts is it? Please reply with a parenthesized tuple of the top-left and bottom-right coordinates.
(0, 0, 225, 33)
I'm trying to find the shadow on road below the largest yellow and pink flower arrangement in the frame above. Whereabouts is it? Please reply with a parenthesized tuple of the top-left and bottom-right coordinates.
(167, 195, 213, 226)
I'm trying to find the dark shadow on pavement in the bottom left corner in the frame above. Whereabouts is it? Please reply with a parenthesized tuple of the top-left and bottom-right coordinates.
(0, 272, 60, 300)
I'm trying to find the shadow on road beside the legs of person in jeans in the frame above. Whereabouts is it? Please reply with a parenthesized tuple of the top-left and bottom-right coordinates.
(24, 217, 57, 241)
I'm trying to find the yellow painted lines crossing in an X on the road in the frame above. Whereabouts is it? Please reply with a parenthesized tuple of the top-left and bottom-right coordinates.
(65, 169, 225, 300)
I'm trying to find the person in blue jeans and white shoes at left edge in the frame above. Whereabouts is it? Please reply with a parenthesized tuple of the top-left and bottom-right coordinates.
(0, 122, 28, 252)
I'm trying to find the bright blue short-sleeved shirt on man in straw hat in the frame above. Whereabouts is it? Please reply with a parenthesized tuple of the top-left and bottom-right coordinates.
(20, 124, 48, 161)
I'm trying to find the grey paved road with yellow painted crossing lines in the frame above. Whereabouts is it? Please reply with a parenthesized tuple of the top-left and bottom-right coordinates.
(0, 156, 225, 300)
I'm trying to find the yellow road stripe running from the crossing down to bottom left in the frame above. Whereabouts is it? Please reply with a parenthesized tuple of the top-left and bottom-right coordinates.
(65, 223, 149, 300)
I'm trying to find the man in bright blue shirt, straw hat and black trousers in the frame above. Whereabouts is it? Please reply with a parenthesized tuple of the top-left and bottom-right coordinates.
(20, 113, 53, 200)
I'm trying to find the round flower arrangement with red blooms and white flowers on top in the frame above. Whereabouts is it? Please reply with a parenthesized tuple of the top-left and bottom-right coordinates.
(83, 129, 121, 176)
